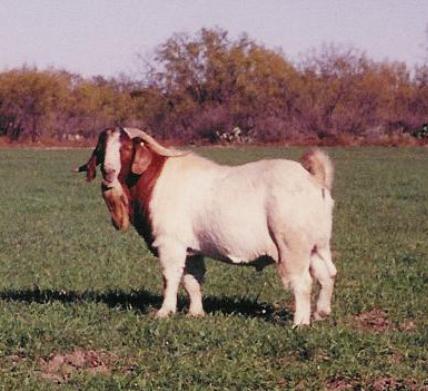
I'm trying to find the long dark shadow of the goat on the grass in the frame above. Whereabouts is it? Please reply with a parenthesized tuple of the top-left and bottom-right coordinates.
(0, 288, 292, 324)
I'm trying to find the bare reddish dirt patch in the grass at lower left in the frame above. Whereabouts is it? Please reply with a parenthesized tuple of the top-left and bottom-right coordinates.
(40, 350, 118, 383)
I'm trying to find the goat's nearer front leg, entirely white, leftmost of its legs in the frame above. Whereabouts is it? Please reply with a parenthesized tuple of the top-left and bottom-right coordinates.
(156, 243, 186, 318)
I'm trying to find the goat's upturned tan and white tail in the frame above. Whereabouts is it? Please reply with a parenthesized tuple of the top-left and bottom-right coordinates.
(300, 148, 334, 190)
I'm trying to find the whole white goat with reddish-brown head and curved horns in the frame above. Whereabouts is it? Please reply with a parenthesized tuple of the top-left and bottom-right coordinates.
(79, 127, 336, 325)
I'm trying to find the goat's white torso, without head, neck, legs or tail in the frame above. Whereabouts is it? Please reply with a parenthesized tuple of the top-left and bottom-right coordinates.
(150, 154, 333, 263)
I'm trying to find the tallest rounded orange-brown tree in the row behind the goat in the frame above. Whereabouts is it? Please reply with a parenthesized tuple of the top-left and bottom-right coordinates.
(135, 29, 298, 140)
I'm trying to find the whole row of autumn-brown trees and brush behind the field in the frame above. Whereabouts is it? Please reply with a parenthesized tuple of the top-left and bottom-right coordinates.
(0, 29, 428, 142)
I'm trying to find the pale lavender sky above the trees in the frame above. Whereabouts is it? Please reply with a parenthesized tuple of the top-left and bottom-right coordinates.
(0, 0, 428, 77)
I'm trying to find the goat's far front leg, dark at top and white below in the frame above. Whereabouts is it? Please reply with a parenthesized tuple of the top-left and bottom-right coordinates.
(182, 256, 206, 316)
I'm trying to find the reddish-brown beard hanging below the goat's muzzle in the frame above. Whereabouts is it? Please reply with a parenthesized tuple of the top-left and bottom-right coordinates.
(101, 184, 129, 231)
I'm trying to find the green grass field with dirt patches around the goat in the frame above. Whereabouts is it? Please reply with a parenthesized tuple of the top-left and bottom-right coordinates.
(0, 148, 428, 390)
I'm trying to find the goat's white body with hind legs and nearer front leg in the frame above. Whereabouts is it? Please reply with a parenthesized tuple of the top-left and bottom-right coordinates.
(150, 154, 335, 325)
